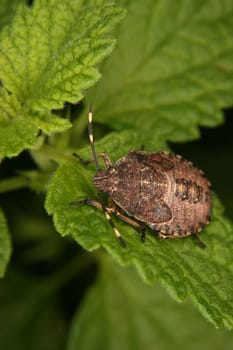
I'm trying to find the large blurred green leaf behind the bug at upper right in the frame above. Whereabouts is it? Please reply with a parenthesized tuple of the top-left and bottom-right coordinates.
(88, 0, 233, 146)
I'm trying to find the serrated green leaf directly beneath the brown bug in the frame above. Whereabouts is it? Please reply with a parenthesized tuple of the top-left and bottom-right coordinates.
(46, 139, 233, 329)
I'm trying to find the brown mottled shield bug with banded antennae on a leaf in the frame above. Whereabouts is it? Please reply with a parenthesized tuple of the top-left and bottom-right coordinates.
(71, 107, 211, 248)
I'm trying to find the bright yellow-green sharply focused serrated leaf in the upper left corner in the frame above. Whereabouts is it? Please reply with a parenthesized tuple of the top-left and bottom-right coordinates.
(0, 0, 123, 156)
